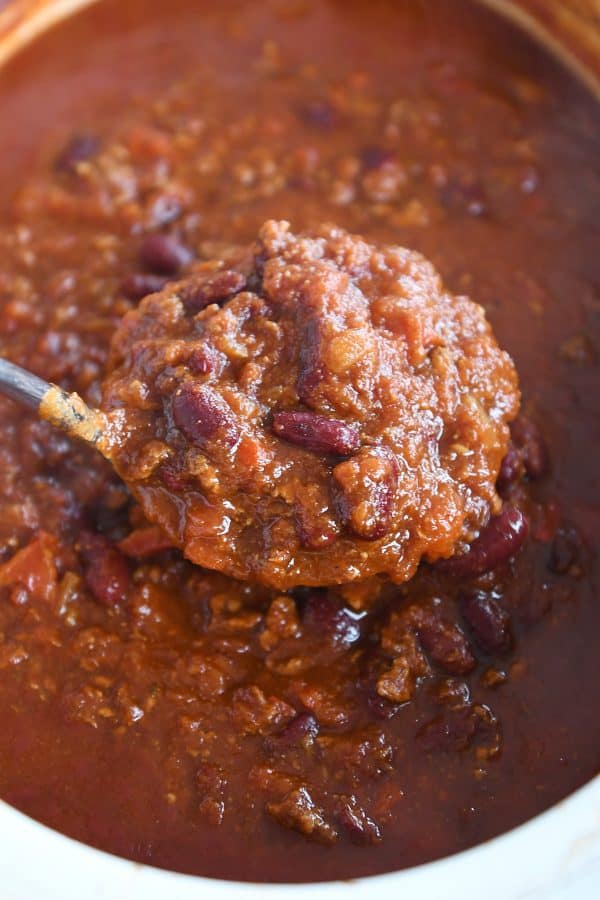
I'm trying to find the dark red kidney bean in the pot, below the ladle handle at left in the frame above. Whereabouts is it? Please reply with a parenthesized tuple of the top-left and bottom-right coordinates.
(79, 532, 130, 606)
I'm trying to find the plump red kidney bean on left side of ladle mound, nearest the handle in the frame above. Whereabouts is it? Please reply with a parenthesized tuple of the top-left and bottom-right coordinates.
(171, 381, 238, 447)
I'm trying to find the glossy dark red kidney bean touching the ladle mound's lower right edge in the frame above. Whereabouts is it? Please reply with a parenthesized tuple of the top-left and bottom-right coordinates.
(436, 503, 529, 578)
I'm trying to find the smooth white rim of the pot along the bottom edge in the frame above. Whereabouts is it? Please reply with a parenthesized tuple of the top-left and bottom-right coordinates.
(0, 776, 600, 900)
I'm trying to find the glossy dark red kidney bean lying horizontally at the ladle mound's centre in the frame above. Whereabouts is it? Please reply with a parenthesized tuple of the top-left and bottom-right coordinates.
(273, 411, 360, 456)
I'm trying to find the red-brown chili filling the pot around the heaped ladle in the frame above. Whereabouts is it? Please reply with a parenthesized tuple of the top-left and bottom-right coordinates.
(0, 0, 600, 881)
